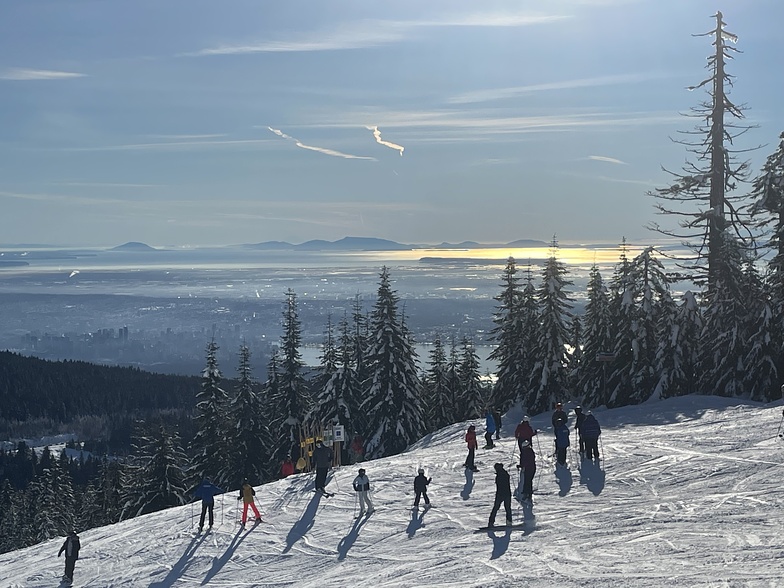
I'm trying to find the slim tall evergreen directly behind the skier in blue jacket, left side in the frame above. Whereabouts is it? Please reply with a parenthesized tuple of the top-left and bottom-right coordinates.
(190, 340, 232, 487)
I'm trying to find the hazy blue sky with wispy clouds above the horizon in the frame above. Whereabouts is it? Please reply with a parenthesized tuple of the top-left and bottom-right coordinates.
(0, 0, 784, 246)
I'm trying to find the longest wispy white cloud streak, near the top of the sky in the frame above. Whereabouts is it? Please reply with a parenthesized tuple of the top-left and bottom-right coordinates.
(185, 12, 569, 57)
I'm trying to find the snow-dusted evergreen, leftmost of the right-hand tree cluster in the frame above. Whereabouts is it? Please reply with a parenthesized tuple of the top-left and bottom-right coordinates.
(490, 257, 528, 412)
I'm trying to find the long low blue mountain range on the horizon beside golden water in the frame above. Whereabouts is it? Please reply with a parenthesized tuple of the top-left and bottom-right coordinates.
(242, 237, 548, 251)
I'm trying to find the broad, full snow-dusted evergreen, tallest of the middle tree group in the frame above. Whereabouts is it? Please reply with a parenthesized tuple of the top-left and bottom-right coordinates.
(362, 266, 424, 458)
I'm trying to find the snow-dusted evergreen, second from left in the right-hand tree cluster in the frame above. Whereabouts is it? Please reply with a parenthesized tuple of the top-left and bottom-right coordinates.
(523, 238, 573, 414)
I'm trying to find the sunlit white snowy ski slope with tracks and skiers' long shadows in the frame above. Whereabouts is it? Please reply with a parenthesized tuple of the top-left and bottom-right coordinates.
(0, 396, 784, 588)
